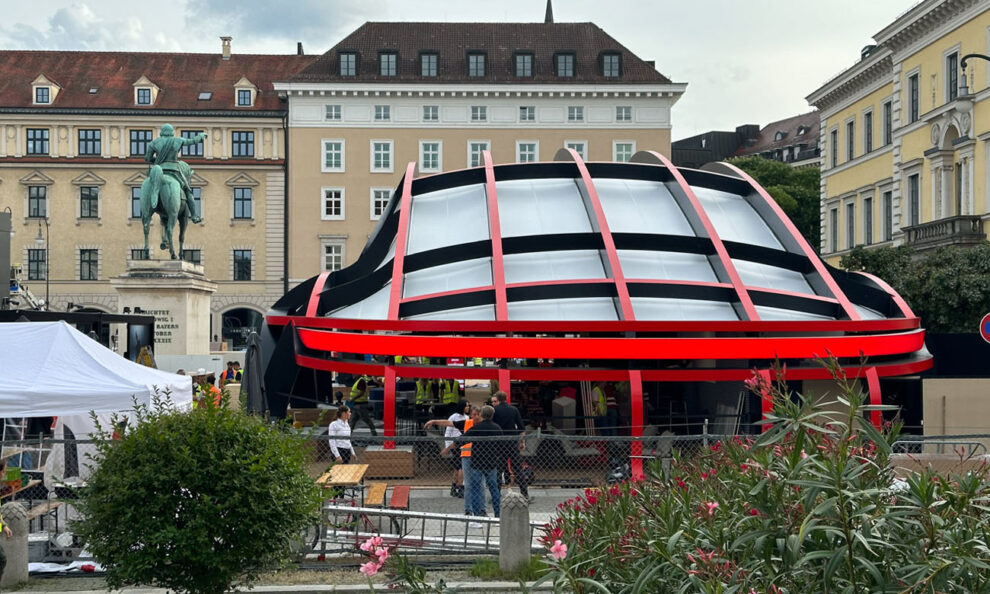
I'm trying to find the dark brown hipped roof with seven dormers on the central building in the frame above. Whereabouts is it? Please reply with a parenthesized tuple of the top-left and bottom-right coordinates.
(291, 23, 670, 84)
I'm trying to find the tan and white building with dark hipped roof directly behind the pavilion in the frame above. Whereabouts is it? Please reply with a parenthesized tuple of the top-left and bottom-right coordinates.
(275, 18, 686, 284)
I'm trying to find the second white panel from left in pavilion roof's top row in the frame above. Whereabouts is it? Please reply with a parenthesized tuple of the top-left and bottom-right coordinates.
(495, 179, 591, 237)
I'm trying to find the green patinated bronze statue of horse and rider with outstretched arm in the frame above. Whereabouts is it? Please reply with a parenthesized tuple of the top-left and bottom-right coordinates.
(141, 124, 206, 260)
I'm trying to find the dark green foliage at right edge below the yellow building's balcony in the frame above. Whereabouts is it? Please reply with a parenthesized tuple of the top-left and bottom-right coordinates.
(840, 242, 990, 333)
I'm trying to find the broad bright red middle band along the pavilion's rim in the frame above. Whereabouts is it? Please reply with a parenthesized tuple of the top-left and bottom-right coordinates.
(297, 328, 925, 359)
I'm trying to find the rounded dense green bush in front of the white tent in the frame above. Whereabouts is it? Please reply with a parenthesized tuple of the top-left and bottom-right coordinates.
(74, 398, 320, 594)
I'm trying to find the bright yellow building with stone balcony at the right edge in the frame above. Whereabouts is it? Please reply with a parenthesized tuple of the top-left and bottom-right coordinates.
(807, 0, 990, 264)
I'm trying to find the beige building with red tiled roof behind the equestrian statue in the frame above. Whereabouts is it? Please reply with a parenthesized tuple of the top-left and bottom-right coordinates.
(0, 38, 312, 346)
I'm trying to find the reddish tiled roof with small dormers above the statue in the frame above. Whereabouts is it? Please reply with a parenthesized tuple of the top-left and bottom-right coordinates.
(0, 51, 314, 111)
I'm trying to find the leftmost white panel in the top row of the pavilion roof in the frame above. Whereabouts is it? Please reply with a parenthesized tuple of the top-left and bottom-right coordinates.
(406, 184, 491, 254)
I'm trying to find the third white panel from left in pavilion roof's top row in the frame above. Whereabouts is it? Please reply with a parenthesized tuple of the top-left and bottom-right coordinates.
(595, 178, 695, 236)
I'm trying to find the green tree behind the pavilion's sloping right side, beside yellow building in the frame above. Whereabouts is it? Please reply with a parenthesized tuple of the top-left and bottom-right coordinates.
(729, 156, 821, 251)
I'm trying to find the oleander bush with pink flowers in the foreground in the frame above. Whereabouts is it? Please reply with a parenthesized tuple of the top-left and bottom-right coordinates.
(542, 358, 990, 594)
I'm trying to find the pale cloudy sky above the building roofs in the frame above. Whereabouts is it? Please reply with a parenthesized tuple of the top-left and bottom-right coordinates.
(0, 0, 915, 139)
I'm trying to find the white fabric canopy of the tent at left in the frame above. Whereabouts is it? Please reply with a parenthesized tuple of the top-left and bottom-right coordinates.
(0, 322, 192, 417)
